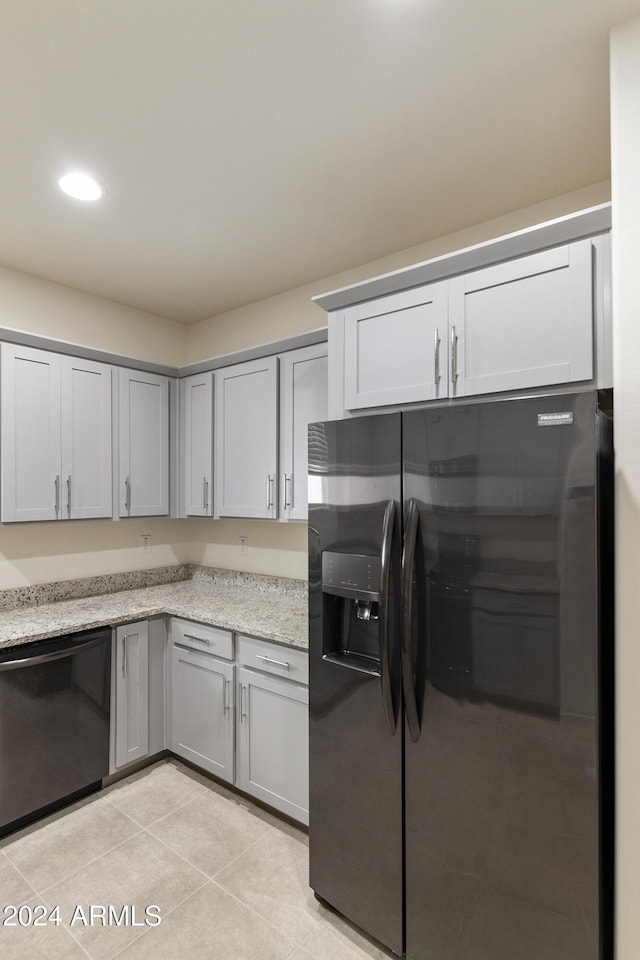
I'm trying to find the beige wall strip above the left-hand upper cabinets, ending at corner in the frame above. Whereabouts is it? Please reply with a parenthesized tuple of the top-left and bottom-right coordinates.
(0, 267, 187, 367)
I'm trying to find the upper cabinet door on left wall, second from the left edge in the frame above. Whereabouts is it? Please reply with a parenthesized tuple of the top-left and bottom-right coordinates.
(61, 357, 112, 519)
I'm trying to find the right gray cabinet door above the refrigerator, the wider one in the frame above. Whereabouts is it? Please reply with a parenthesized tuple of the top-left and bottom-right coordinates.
(449, 240, 593, 396)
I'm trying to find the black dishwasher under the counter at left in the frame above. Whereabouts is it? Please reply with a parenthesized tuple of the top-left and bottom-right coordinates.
(0, 628, 111, 835)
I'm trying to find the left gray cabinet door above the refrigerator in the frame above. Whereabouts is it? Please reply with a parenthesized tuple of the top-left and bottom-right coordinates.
(344, 283, 448, 410)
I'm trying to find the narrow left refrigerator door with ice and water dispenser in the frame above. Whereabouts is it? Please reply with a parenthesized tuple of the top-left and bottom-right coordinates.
(309, 414, 403, 954)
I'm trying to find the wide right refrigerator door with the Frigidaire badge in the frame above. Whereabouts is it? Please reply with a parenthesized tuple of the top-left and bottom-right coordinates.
(403, 394, 600, 960)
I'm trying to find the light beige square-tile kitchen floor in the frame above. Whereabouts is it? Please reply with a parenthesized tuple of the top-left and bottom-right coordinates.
(0, 760, 392, 960)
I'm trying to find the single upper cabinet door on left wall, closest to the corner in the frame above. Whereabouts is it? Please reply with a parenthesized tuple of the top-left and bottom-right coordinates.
(119, 369, 169, 517)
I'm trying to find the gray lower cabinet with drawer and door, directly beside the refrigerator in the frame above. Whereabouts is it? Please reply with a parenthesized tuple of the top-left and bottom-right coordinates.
(236, 637, 309, 824)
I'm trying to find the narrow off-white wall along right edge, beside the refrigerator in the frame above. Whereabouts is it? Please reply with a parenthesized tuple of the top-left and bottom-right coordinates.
(611, 18, 640, 960)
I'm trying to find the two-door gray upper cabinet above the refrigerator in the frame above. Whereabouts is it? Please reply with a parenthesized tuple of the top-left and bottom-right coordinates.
(329, 235, 611, 418)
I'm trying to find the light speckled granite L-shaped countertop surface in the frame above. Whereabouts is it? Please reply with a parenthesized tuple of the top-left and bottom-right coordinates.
(0, 578, 309, 649)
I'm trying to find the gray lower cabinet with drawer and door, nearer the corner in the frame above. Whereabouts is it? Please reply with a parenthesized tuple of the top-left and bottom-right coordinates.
(168, 618, 235, 783)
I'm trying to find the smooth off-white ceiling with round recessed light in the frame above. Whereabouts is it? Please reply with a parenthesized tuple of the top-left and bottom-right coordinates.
(0, 0, 640, 323)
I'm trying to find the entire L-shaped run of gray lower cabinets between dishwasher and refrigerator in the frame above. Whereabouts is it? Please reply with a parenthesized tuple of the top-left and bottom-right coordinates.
(110, 617, 309, 824)
